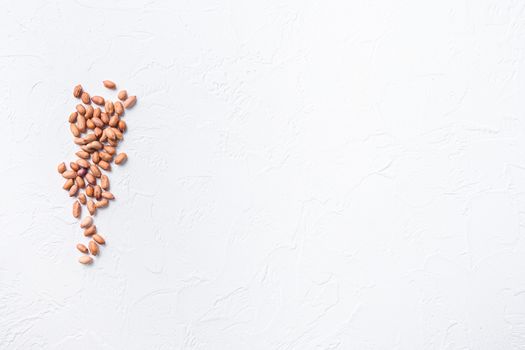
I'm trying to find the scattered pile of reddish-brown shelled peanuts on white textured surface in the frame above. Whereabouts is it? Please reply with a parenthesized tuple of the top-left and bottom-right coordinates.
(58, 80, 137, 264)
